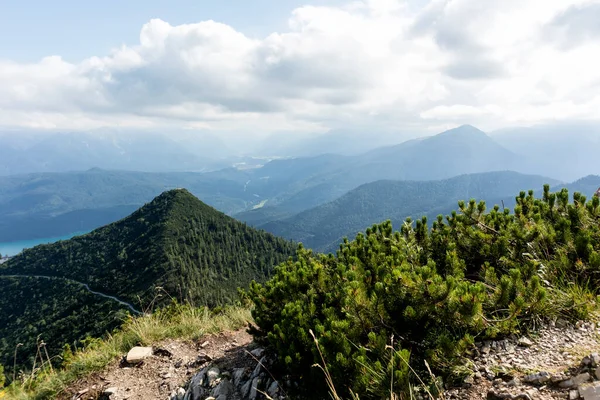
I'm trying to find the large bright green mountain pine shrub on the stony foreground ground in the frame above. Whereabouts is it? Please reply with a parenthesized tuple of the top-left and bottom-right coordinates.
(248, 186, 600, 399)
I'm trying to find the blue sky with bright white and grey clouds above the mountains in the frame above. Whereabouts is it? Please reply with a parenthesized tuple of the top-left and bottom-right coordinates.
(0, 0, 600, 133)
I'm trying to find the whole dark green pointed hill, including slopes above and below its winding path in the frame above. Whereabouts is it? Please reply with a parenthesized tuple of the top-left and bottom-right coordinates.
(0, 189, 296, 372)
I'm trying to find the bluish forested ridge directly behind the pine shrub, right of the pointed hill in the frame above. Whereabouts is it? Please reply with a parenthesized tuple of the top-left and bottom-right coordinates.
(255, 171, 584, 251)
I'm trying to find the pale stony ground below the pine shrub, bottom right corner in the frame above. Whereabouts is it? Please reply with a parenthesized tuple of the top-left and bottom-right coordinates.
(445, 323, 600, 400)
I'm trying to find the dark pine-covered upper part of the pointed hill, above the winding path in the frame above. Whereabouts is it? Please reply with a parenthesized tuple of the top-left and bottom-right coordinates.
(0, 189, 295, 305)
